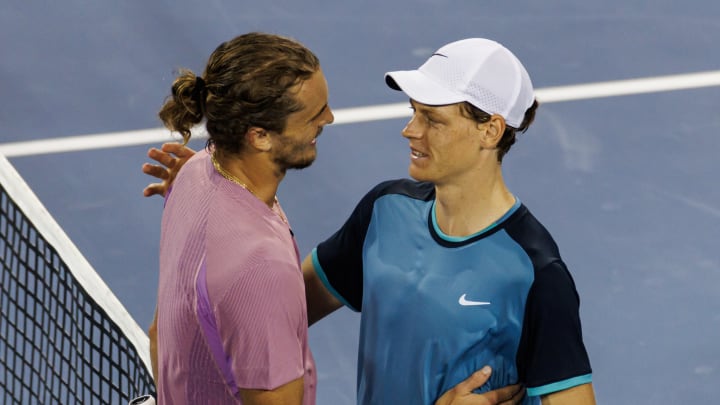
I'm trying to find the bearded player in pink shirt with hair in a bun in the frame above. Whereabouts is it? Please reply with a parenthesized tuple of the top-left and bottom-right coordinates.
(153, 33, 333, 405)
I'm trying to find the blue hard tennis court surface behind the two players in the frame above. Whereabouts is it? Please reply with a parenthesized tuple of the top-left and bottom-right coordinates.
(0, 0, 720, 405)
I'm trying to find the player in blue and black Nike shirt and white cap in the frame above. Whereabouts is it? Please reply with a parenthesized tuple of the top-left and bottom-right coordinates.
(303, 38, 595, 405)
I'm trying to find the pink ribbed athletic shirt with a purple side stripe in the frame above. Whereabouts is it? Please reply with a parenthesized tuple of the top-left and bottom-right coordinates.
(157, 151, 317, 405)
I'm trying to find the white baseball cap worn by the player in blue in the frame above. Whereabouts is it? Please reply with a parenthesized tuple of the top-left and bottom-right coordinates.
(385, 38, 535, 128)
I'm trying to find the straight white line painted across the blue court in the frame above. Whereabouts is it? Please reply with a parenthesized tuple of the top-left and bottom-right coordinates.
(0, 70, 720, 157)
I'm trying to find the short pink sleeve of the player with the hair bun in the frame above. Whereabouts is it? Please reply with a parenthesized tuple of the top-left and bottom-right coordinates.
(213, 258, 307, 390)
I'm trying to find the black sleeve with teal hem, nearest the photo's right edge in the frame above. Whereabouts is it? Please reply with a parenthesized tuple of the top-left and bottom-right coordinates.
(518, 260, 592, 396)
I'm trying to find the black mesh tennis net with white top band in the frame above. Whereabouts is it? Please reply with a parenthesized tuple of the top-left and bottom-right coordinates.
(0, 155, 155, 404)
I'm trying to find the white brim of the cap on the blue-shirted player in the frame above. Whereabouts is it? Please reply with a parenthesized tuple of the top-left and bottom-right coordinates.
(385, 70, 466, 105)
